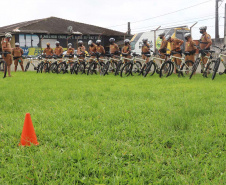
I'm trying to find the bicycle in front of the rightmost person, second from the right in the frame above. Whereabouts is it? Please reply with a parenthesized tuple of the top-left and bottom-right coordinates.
(190, 50, 215, 79)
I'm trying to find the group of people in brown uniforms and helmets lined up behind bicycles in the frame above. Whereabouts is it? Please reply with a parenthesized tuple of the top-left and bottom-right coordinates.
(1, 26, 212, 77)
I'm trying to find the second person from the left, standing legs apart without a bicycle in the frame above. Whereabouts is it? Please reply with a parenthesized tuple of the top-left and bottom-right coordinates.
(12, 42, 24, 72)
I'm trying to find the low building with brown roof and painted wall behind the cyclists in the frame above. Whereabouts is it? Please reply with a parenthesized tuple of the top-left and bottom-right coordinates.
(0, 17, 128, 55)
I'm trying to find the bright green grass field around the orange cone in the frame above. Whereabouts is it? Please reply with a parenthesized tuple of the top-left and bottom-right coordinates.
(0, 72, 226, 185)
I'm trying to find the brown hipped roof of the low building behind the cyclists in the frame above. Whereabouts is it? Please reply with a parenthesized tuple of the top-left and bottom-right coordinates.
(0, 17, 124, 36)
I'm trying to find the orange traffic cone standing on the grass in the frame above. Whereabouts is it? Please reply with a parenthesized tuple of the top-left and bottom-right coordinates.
(19, 113, 39, 146)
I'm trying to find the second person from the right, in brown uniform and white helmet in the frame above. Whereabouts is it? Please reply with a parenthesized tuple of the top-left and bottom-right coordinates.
(184, 33, 197, 62)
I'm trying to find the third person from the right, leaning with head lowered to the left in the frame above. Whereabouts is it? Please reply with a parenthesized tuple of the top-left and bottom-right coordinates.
(166, 35, 184, 73)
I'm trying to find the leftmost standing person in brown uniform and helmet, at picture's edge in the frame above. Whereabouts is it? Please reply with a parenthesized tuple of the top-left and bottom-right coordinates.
(1, 33, 12, 77)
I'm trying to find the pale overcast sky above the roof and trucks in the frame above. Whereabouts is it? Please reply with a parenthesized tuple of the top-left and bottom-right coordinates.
(0, 0, 226, 39)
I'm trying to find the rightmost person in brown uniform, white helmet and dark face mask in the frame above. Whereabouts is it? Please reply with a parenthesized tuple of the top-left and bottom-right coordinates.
(199, 26, 212, 73)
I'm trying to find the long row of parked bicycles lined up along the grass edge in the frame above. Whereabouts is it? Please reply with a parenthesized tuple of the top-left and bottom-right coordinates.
(10, 46, 226, 79)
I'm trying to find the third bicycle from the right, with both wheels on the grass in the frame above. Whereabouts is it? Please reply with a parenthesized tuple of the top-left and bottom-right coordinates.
(159, 51, 194, 78)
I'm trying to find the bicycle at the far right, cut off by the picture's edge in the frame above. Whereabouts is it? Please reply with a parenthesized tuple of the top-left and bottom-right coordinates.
(212, 45, 226, 80)
